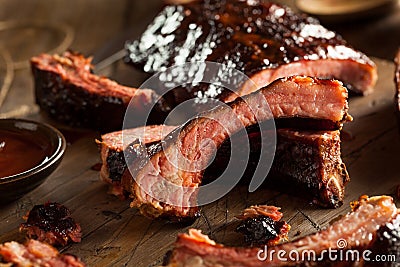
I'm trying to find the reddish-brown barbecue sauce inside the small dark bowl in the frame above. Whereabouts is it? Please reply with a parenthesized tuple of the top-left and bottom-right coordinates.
(0, 129, 52, 178)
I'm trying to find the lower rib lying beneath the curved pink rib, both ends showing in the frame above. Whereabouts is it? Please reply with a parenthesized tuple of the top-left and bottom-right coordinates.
(97, 125, 350, 207)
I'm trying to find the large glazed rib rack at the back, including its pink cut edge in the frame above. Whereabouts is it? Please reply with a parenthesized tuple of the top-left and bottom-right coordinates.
(125, 0, 377, 104)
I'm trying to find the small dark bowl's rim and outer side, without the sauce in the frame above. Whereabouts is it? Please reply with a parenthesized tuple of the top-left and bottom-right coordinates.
(0, 119, 66, 204)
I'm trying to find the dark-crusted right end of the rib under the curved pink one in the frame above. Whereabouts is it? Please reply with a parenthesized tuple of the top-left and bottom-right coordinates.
(269, 129, 350, 207)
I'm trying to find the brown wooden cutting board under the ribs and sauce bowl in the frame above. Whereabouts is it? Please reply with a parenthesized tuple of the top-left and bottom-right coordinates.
(0, 59, 400, 266)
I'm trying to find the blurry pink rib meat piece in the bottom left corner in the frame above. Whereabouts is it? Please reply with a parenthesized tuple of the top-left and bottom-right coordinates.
(0, 239, 85, 267)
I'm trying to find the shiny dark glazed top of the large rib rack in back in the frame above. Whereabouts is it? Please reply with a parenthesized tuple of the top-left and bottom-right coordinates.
(125, 0, 373, 103)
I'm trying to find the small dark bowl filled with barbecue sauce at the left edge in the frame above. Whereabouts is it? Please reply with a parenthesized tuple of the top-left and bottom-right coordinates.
(0, 119, 66, 204)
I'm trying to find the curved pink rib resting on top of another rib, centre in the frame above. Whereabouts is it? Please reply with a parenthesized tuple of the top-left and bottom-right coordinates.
(122, 76, 349, 218)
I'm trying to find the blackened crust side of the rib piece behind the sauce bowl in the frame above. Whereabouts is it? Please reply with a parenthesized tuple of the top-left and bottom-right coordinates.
(33, 60, 127, 130)
